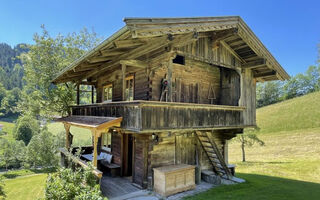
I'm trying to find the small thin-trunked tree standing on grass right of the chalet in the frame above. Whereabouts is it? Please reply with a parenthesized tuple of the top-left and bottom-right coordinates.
(235, 130, 265, 162)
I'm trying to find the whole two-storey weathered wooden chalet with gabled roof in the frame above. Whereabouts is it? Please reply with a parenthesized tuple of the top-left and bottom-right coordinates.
(53, 16, 289, 197)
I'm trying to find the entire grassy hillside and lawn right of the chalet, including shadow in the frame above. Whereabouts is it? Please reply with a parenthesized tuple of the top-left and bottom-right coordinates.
(186, 92, 320, 200)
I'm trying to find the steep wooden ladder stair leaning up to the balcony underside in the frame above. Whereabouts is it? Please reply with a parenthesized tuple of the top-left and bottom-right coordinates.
(196, 131, 232, 179)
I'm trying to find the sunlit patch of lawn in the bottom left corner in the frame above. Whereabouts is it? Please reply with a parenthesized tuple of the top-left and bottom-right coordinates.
(4, 174, 47, 200)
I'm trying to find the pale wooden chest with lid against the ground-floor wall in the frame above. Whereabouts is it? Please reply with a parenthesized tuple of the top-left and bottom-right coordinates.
(153, 164, 196, 197)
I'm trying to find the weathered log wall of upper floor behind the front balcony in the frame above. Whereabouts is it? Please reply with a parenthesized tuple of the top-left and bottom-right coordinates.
(150, 62, 220, 104)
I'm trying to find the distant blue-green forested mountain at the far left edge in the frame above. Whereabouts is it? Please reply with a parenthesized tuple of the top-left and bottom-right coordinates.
(0, 43, 29, 90)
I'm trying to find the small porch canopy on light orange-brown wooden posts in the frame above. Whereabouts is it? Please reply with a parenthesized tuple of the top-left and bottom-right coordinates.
(56, 116, 122, 167)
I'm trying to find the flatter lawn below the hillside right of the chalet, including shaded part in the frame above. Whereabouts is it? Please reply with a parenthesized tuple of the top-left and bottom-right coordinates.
(186, 128, 320, 200)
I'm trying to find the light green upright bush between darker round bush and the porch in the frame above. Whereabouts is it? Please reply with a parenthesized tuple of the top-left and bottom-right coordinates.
(26, 128, 57, 167)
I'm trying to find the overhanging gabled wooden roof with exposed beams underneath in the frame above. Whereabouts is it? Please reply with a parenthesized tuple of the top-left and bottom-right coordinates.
(52, 16, 290, 83)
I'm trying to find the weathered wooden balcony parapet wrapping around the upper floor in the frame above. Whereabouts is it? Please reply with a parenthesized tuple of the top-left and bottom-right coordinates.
(71, 100, 245, 132)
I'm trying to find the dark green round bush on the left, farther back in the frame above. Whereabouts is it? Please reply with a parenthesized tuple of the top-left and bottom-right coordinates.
(13, 115, 40, 145)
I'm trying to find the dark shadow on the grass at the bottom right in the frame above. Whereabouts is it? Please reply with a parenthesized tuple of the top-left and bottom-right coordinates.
(185, 173, 320, 200)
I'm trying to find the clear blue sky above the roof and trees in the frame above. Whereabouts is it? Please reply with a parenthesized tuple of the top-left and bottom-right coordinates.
(0, 0, 320, 75)
